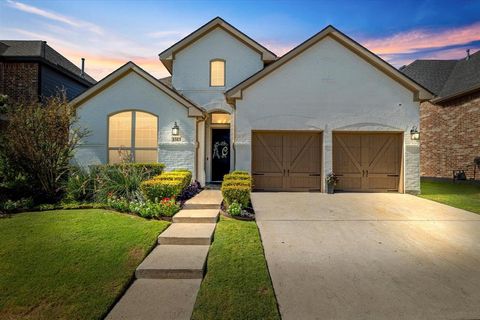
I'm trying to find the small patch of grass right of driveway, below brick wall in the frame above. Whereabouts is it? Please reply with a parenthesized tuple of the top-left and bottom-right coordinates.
(420, 181, 480, 214)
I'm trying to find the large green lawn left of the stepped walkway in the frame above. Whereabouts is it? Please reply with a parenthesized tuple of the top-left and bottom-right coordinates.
(0, 209, 168, 320)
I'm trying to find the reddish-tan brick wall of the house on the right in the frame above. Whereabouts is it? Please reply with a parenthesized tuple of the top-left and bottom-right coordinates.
(420, 92, 480, 180)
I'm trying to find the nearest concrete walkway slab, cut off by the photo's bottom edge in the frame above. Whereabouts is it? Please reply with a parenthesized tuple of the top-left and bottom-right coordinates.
(105, 279, 202, 320)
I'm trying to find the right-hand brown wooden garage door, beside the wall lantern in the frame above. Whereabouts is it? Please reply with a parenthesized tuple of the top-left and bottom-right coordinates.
(333, 133, 402, 192)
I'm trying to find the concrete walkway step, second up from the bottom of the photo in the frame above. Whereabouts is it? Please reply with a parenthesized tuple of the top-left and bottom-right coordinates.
(135, 245, 209, 279)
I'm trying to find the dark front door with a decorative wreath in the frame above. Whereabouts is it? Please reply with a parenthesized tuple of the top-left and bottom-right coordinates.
(212, 129, 230, 181)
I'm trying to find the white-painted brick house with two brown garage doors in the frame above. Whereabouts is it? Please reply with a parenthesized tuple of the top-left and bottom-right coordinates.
(72, 17, 432, 193)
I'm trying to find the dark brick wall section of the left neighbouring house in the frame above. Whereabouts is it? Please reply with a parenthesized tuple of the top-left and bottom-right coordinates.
(0, 62, 39, 101)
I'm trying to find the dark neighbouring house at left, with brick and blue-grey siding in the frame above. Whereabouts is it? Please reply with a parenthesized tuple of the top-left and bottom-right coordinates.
(0, 40, 96, 101)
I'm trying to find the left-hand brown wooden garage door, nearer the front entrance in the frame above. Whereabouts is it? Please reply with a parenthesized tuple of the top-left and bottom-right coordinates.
(252, 131, 322, 191)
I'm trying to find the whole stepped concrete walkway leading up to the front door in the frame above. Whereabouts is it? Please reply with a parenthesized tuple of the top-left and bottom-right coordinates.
(106, 190, 222, 320)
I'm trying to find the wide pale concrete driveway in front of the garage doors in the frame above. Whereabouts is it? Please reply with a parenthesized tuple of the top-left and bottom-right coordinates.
(252, 193, 480, 320)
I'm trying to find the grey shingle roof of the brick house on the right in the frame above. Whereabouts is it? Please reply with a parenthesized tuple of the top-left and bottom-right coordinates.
(400, 51, 480, 100)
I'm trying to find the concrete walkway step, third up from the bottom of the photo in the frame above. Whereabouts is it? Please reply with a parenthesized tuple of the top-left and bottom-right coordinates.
(158, 223, 216, 246)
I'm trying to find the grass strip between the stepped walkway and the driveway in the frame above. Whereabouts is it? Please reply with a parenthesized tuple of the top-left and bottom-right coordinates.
(192, 217, 280, 320)
